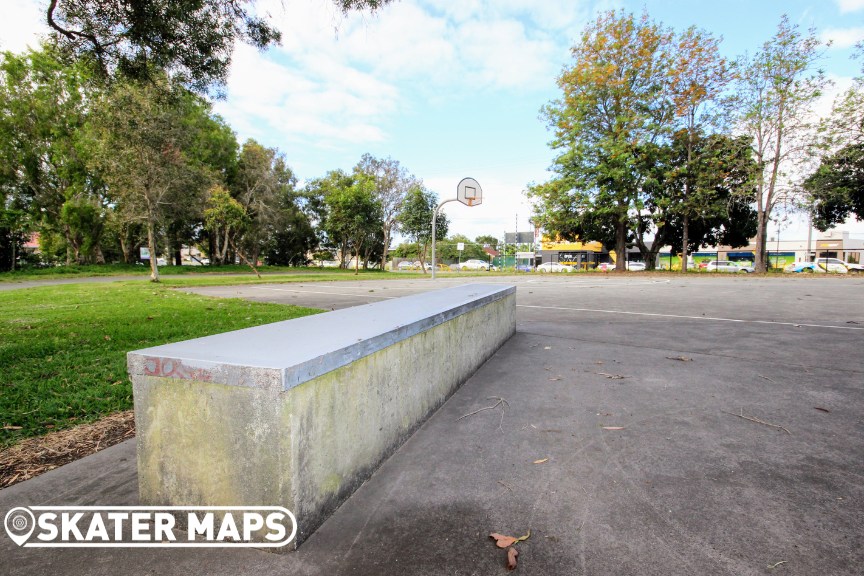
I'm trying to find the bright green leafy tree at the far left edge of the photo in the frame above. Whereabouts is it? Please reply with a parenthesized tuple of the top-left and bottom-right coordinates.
(0, 45, 108, 264)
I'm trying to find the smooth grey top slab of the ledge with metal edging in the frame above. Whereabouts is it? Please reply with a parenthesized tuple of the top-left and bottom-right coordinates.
(128, 284, 516, 390)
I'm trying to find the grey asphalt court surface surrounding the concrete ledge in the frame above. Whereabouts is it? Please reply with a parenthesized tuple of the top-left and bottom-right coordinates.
(0, 274, 864, 576)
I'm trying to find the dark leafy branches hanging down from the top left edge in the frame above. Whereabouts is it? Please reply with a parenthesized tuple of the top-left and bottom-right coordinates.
(46, 0, 390, 91)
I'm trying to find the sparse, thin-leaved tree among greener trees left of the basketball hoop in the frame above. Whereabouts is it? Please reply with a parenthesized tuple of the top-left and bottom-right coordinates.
(354, 154, 420, 270)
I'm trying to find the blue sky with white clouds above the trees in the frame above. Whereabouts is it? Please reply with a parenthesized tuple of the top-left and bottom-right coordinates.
(0, 0, 864, 240)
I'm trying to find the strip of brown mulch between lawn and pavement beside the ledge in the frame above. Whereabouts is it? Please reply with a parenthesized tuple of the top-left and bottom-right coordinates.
(0, 410, 135, 488)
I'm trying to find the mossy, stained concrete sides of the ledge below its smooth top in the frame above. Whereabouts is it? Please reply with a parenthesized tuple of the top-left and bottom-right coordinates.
(132, 291, 516, 545)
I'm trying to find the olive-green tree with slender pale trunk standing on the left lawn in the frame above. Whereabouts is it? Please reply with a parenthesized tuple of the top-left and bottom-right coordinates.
(92, 79, 211, 282)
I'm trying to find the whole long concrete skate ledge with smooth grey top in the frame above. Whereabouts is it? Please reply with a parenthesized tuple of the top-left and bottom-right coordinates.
(128, 284, 516, 544)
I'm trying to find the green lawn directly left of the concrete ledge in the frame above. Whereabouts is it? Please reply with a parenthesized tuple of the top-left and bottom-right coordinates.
(0, 282, 318, 446)
